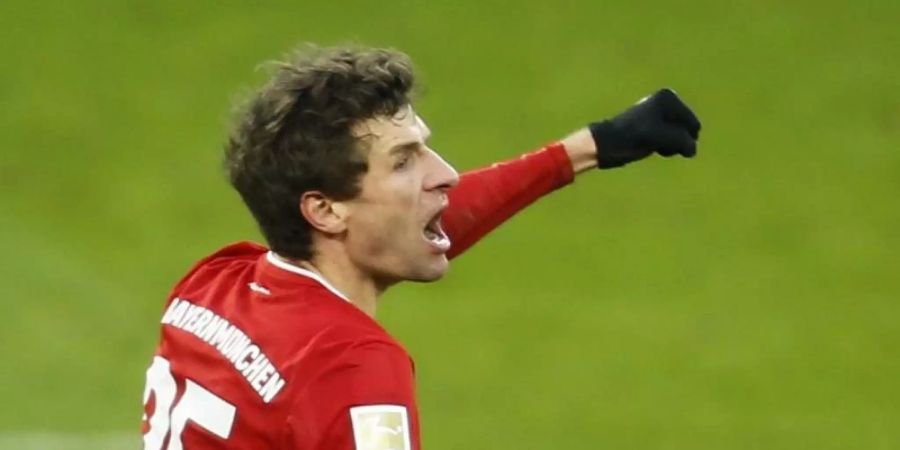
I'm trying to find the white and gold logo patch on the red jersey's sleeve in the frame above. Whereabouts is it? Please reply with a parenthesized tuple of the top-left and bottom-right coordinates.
(350, 405, 412, 450)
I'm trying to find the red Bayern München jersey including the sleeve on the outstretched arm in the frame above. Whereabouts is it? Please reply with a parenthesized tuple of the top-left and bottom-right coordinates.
(143, 144, 573, 450)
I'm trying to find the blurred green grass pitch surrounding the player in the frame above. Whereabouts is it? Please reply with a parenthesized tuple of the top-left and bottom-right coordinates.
(0, 0, 900, 450)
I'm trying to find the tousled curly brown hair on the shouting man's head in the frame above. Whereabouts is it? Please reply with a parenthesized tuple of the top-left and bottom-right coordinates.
(225, 46, 414, 259)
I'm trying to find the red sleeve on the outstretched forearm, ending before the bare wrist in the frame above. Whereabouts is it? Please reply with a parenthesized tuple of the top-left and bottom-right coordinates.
(441, 143, 575, 258)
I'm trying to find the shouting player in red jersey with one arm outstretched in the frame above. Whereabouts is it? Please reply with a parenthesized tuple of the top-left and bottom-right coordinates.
(144, 44, 700, 450)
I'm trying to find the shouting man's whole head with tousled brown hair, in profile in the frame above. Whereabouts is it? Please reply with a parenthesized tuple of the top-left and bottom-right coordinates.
(225, 48, 458, 285)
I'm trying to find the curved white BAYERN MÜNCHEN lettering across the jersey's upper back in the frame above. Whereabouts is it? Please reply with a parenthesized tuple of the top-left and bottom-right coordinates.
(160, 297, 287, 403)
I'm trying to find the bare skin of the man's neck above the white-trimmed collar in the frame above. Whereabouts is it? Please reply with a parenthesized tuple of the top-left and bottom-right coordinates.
(286, 254, 384, 318)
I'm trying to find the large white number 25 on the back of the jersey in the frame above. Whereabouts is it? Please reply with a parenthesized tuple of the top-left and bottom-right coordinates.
(144, 356, 235, 450)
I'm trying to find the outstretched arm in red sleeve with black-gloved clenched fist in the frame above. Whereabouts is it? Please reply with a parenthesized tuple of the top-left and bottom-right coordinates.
(442, 89, 700, 258)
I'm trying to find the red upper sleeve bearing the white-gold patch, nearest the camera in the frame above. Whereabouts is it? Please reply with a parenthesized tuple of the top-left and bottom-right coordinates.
(284, 342, 421, 450)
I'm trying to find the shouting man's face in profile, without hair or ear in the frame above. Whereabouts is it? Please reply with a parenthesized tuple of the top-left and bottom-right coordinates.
(342, 107, 459, 286)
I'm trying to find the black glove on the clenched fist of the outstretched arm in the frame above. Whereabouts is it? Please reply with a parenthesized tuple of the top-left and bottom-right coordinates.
(588, 89, 700, 169)
